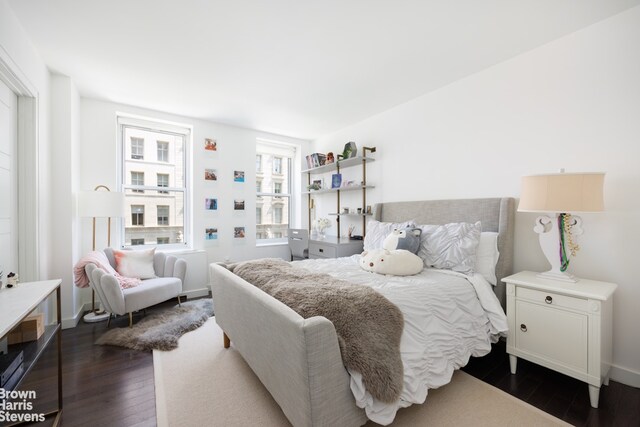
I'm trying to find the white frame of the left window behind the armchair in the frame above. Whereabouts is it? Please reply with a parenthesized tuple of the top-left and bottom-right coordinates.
(116, 112, 193, 251)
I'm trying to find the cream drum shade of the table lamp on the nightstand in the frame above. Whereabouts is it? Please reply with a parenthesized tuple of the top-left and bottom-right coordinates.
(518, 172, 604, 213)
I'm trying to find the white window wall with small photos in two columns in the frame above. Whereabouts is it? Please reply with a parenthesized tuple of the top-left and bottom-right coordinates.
(80, 98, 308, 290)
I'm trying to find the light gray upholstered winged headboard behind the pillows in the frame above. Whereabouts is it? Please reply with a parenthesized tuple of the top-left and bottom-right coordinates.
(374, 197, 515, 307)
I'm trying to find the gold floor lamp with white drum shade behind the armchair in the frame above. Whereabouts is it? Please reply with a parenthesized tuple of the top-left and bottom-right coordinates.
(78, 185, 124, 323)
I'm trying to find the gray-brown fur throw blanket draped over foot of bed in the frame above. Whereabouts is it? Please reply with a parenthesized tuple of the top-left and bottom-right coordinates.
(228, 259, 404, 403)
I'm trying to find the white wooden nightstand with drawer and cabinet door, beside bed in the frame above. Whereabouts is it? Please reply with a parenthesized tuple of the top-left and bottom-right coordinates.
(502, 271, 617, 408)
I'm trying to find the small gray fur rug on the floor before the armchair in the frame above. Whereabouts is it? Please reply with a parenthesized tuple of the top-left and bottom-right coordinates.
(96, 298, 213, 351)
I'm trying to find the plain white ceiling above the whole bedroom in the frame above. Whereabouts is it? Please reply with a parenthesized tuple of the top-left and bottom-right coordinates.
(9, 0, 640, 139)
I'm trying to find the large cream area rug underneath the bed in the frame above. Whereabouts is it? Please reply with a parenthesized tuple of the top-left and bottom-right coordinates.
(153, 318, 569, 427)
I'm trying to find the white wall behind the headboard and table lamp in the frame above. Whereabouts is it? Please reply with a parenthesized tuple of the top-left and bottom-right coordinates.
(314, 7, 640, 386)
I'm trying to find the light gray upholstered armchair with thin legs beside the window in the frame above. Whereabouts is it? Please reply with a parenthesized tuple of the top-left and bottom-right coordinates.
(85, 248, 187, 327)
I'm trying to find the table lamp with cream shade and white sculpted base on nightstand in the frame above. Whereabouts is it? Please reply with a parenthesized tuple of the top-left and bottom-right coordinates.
(518, 170, 604, 282)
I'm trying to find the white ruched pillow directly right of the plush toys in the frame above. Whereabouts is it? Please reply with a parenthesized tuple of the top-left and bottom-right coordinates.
(418, 221, 482, 274)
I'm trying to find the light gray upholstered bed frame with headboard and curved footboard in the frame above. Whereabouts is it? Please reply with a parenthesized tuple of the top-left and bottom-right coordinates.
(210, 198, 515, 426)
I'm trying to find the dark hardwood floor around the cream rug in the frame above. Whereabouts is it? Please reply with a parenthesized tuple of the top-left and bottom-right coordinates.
(11, 301, 640, 427)
